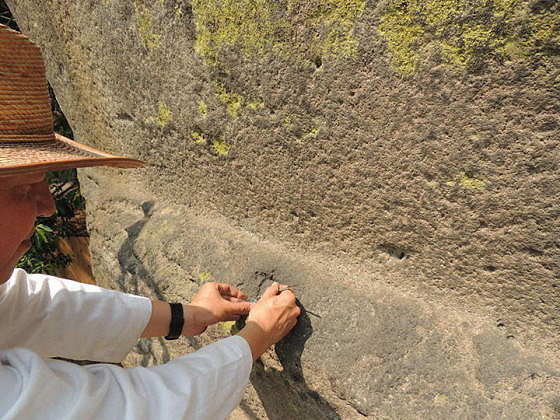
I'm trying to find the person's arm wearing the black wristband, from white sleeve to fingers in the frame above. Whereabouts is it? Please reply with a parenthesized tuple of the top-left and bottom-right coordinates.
(0, 270, 251, 362)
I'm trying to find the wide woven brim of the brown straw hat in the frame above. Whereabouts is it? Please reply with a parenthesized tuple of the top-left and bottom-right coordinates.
(0, 133, 144, 176)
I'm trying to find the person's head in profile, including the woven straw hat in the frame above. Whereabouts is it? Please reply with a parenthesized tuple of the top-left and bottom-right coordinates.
(0, 24, 142, 283)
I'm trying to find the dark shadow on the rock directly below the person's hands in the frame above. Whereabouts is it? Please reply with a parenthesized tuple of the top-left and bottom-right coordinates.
(251, 301, 340, 420)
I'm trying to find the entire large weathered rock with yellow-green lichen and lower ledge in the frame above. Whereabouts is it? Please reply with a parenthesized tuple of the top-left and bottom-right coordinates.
(7, 0, 560, 419)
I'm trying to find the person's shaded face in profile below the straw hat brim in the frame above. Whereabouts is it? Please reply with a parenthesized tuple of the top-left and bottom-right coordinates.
(0, 172, 55, 283)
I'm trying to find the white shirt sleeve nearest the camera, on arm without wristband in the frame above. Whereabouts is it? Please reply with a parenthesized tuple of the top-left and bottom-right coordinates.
(0, 336, 252, 420)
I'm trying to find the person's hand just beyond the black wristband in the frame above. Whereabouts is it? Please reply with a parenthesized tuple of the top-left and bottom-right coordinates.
(182, 283, 251, 336)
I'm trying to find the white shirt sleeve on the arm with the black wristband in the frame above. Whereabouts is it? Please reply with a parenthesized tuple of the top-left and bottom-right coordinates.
(0, 269, 152, 362)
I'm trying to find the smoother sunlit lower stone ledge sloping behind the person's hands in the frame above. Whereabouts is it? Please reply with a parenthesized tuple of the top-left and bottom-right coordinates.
(81, 170, 560, 420)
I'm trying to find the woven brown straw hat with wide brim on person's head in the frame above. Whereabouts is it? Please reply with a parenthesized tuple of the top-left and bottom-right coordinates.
(0, 25, 142, 176)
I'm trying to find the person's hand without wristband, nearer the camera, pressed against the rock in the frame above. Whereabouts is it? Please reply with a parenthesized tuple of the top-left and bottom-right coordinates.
(239, 283, 301, 359)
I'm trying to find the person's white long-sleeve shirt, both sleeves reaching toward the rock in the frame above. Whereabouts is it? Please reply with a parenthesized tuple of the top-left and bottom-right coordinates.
(0, 269, 252, 420)
